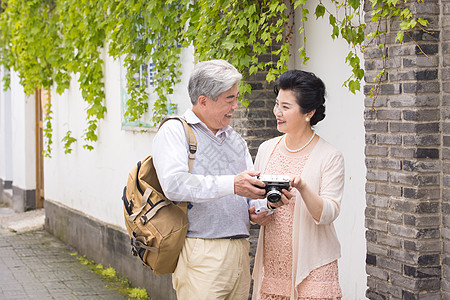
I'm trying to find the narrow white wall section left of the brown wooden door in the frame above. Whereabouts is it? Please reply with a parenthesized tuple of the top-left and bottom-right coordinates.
(10, 72, 36, 190)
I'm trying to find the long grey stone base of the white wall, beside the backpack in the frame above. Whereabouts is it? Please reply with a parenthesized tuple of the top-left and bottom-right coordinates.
(45, 200, 176, 300)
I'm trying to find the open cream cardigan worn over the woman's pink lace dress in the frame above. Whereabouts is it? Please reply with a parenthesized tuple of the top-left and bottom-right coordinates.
(252, 137, 345, 300)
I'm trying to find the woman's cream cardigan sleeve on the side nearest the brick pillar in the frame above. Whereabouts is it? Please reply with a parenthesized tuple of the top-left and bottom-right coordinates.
(316, 151, 345, 224)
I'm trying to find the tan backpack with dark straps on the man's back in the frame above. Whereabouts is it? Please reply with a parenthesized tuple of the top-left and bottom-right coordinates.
(122, 117, 197, 275)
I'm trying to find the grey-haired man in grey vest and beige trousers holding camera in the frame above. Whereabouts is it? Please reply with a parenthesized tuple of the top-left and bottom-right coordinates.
(153, 60, 265, 300)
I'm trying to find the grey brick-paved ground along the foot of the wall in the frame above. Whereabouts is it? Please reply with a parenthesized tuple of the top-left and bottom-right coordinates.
(0, 207, 126, 300)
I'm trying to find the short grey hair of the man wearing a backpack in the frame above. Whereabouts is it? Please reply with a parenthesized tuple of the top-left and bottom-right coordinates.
(188, 59, 242, 105)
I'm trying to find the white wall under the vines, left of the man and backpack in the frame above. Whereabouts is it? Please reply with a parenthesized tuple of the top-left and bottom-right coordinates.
(44, 49, 193, 228)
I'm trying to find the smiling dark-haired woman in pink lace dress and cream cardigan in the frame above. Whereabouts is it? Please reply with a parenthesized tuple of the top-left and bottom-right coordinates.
(249, 70, 344, 300)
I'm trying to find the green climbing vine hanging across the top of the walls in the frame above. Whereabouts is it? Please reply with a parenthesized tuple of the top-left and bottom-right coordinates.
(0, 0, 427, 155)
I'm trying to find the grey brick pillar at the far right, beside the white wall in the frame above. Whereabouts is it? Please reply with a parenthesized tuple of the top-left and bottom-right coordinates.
(364, 0, 444, 299)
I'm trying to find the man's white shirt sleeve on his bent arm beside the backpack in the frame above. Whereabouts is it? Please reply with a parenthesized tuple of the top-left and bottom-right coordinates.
(153, 120, 236, 203)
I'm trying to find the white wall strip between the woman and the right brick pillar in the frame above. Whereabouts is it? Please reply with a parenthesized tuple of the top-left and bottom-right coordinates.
(293, 1, 366, 300)
